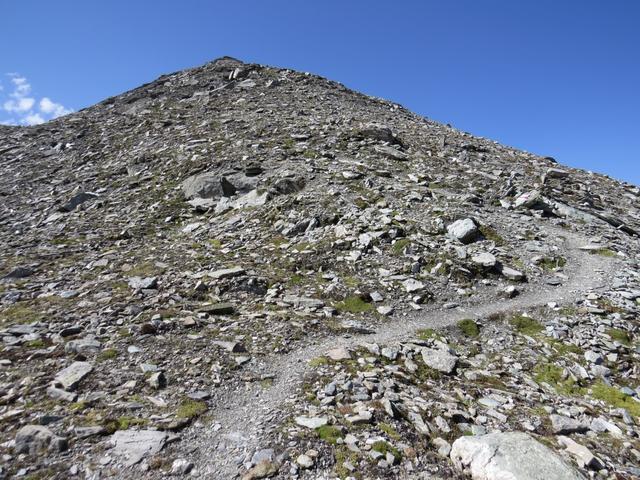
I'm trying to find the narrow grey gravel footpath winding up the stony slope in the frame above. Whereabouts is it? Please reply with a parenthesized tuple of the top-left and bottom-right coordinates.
(188, 226, 616, 479)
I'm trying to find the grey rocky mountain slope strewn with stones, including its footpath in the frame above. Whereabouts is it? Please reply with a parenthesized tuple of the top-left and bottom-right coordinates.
(0, 58, 640, 479)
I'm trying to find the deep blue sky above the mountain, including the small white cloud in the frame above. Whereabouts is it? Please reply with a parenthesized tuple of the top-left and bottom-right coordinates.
(0, 0, 640, 184)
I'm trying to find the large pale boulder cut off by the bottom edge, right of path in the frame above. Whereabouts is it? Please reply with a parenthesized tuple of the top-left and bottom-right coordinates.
(451, 432, 584, 480)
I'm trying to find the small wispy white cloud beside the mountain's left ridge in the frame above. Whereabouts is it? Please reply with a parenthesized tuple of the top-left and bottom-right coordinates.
(0, 73, 73, 125)
